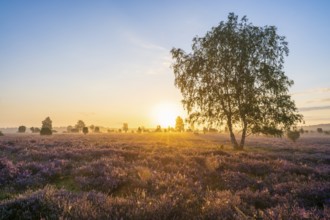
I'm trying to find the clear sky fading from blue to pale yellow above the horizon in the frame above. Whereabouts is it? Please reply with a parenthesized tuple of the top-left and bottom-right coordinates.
(0, 0, 330, 127)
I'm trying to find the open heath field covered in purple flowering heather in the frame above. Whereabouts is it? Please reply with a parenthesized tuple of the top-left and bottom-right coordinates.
(0, 133, 330, 219)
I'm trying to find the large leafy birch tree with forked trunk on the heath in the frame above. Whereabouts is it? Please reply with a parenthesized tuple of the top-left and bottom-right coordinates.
(171, 13, 303, 150)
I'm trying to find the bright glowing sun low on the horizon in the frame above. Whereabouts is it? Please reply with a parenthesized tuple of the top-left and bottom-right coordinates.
(152, 102, 182, 128)
